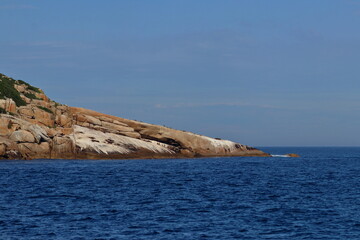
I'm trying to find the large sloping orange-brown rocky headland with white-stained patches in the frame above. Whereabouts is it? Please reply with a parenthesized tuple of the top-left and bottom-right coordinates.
(0, 74, 269, 159)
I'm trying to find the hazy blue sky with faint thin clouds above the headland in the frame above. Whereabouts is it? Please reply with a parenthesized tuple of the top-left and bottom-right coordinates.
(0, 0, 360, 146)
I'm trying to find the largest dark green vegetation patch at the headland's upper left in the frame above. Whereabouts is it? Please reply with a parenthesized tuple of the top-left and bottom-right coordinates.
(0, 74, 26, 107)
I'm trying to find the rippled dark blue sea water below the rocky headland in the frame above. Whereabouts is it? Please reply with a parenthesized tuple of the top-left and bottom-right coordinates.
(0, 148, 360, 240)
